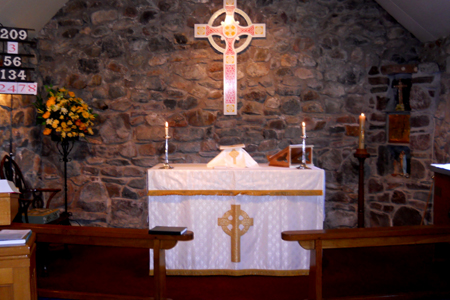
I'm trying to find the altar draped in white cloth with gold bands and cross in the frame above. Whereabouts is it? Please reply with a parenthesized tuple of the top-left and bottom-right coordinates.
(148, 164, 325, 276)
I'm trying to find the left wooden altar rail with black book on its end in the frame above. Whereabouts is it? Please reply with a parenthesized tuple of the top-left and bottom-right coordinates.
(2, 223, 194, 300)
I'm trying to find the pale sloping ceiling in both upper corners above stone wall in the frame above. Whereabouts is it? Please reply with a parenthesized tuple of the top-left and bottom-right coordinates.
(0, 0, 450, 42)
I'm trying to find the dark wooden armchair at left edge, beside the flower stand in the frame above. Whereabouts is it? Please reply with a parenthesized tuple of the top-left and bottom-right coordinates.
(0, 155, 62, 225)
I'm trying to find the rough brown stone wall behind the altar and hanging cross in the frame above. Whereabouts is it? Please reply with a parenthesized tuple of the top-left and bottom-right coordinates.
(0, 0, 442, 228)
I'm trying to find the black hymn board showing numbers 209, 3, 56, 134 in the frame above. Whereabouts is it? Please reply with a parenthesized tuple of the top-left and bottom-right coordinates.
(0, 27, 37, 95)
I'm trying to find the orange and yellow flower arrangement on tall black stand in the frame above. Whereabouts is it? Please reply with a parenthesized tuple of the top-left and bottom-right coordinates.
(34, 86, 97, 141)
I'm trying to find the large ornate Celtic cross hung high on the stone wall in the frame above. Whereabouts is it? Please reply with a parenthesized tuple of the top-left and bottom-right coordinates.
(194, 0, 266, 115)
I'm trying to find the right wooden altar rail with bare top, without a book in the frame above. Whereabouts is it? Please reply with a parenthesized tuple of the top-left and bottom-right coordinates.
(281, 225, 450, 300)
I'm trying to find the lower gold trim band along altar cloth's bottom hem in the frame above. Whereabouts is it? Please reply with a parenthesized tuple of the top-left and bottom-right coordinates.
(149, 269, 309, 276)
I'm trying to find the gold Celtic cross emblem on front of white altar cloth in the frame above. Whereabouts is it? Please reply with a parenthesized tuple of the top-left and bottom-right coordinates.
(218, 204, 253, 262)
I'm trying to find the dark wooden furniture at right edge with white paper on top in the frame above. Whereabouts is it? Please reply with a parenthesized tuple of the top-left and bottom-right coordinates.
(430, 165, 450, 225)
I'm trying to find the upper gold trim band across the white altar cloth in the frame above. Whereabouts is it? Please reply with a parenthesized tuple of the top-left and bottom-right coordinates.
(147, 190, 323, 196)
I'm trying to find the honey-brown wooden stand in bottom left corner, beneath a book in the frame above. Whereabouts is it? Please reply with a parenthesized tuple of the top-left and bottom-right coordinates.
(0, 233, 37, 300)
